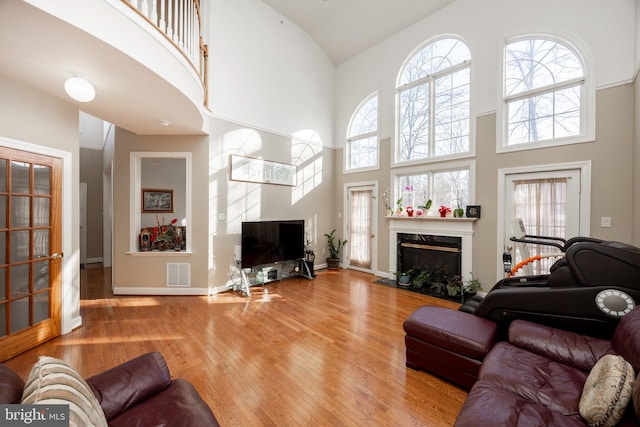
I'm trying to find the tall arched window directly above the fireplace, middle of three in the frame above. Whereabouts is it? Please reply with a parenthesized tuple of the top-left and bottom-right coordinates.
(396, 37, 471, 162)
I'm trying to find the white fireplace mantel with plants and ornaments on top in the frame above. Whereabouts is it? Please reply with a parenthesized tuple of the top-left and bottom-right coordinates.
(386, 216, 477, 281)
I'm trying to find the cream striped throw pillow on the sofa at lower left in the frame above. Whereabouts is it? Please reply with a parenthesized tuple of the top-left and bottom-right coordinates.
(21, 356, 107, 427)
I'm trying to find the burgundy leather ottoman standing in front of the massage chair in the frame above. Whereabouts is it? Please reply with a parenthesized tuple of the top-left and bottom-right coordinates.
(403, 306, 498, 390)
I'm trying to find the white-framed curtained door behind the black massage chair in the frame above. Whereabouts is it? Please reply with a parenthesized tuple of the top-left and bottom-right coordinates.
(499, 163, 590, 275)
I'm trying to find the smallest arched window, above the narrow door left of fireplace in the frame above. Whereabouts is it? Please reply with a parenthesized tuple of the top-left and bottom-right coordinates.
(345, 93, 379, 170)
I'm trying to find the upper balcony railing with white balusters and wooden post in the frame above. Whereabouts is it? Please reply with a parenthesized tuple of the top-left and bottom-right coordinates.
(122, 0, 209, 106)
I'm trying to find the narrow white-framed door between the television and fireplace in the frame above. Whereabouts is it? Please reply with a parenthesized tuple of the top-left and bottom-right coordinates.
(344, 183, 378, 273)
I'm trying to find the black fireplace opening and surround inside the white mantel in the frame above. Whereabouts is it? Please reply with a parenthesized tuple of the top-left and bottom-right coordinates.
(396, 233, 462, 276)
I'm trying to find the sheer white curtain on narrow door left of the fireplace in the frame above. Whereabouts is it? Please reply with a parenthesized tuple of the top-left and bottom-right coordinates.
(349, 190, 373, 269)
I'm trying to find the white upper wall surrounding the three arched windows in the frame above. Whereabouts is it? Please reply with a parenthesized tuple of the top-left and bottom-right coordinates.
(335, 0, 635, 146)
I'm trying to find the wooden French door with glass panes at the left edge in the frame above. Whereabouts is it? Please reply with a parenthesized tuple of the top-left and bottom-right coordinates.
(0, 147, 62, 360)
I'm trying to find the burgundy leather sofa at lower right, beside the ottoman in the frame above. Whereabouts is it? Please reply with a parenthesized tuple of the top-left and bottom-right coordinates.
(456, 307, 640, 427)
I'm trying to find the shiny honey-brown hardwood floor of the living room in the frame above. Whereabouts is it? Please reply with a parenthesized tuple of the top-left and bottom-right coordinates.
(5, 266, 467, 426)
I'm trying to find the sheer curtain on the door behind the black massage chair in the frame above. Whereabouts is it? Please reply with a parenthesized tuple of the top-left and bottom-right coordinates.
(513, 178, 567, 274)
